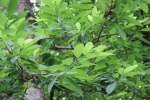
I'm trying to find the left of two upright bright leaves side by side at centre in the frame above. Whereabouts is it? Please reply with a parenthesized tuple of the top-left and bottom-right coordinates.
(73, 44, 84, 58)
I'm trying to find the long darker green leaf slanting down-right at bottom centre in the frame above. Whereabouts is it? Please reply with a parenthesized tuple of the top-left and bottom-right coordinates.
(64, 76, 83, 96)
